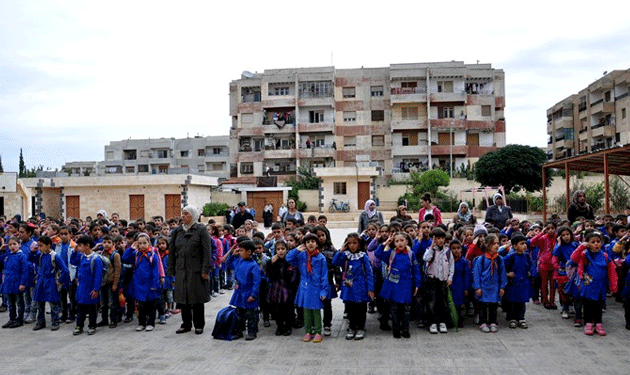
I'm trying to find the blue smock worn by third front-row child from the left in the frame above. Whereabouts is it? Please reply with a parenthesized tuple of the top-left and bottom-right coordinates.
(70, 251, 103, 305)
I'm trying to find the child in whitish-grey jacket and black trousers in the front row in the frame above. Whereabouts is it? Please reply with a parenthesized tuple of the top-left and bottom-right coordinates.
(423, 228, 455, 334)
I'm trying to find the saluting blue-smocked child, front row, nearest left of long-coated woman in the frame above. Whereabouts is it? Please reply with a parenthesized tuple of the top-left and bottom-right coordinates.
(122, 233, 164, 332)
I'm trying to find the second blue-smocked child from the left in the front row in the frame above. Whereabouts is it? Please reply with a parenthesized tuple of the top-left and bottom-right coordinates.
(28, 236, 70, 331)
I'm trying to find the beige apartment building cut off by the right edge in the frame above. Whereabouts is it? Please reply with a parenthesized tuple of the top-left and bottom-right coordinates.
(547, 69, 630, 160)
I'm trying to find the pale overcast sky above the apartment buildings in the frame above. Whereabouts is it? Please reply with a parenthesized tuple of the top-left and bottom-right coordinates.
(0, 0, 630, 171)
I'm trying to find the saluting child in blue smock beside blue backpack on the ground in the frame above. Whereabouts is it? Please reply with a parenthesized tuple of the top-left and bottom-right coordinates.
(224, 240, 261, 341)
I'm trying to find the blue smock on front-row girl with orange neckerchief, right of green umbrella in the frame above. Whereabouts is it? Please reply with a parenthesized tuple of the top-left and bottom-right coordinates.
(473, 255, 507, 303)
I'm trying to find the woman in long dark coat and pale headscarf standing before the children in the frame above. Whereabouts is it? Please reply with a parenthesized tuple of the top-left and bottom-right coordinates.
(167, 206, 213, 334)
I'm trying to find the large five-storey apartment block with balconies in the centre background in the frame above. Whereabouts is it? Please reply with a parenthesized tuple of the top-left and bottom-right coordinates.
(230, 61, 505, 178)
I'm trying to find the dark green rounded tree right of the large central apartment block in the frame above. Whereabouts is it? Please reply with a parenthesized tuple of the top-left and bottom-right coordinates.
(475, 145, 552, 193)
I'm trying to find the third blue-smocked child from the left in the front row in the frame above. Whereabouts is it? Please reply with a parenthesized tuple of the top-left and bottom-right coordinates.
(70, 236, 103, 336)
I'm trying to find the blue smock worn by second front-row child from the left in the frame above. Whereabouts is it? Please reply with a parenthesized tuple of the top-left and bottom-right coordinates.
(28, 251, 70, 302)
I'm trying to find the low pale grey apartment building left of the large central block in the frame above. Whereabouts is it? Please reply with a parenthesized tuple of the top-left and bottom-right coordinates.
(63, 136, 230, 178)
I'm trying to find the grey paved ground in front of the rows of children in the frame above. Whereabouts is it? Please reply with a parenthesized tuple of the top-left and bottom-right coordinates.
(0, 229, 630, 375)
